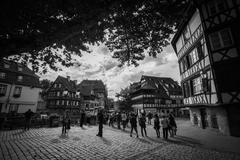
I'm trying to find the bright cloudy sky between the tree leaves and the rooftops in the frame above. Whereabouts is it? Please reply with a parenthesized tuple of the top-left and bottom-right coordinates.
(41, 45, 180, 99)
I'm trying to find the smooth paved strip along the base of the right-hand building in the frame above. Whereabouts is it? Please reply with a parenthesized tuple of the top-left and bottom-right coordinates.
(176, 120, 240, 154)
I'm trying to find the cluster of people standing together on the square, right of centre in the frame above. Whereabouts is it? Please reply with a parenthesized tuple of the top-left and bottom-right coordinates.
(109, 112, 177, 139)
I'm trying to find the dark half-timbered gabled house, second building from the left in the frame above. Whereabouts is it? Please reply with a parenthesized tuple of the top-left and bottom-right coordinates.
(46, 76, 82, 114)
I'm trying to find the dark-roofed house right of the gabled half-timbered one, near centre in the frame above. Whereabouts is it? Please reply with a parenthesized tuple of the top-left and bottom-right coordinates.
(78, 80, 107, 110)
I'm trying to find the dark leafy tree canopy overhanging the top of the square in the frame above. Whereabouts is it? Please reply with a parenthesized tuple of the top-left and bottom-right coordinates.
(0, 0, 188, 71)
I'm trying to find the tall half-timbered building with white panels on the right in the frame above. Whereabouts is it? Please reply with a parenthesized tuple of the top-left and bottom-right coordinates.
(172, 0, 240, 136)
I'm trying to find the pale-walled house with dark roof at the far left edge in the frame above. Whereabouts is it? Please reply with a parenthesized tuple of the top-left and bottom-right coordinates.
(0, 59, 41, 113)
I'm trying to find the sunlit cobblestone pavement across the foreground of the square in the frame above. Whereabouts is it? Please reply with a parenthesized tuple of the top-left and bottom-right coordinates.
(0, 126, 240, 160)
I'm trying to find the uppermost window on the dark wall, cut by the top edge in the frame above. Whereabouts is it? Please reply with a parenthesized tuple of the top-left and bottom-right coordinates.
(208, 0, 226, 15)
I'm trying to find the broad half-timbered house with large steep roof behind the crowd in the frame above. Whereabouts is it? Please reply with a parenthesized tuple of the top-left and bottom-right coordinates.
(130, 75, 183, 114)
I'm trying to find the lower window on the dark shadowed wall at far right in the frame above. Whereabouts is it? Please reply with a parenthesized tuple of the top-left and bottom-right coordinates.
(209, 29, 233, 50)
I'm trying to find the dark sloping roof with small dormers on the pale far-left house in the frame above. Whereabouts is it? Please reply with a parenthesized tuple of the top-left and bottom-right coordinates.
(0, 59, 40, 88)
